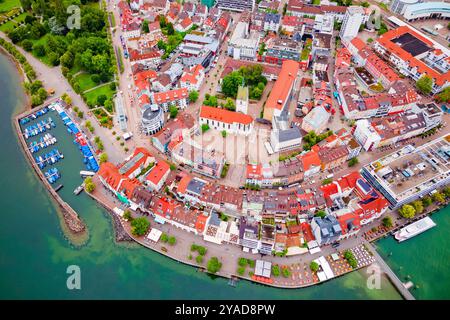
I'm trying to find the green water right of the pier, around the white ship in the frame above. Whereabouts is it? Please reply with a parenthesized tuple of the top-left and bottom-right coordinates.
(377, 206, 450, 299)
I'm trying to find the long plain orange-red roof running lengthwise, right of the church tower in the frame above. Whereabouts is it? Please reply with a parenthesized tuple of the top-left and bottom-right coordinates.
(265, 60, 300, 110)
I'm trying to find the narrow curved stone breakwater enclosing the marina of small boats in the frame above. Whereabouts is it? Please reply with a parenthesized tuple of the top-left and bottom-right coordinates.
(14, 98, 86, 235)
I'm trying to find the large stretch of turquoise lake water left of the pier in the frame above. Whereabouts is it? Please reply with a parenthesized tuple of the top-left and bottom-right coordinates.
(0, 54, 400, 299)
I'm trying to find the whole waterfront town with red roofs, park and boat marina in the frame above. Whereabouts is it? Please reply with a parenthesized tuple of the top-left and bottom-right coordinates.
(0, 0, 450, 300)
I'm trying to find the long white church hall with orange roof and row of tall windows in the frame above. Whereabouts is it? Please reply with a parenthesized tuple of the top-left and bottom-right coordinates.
(199, 106, 253, 135)
